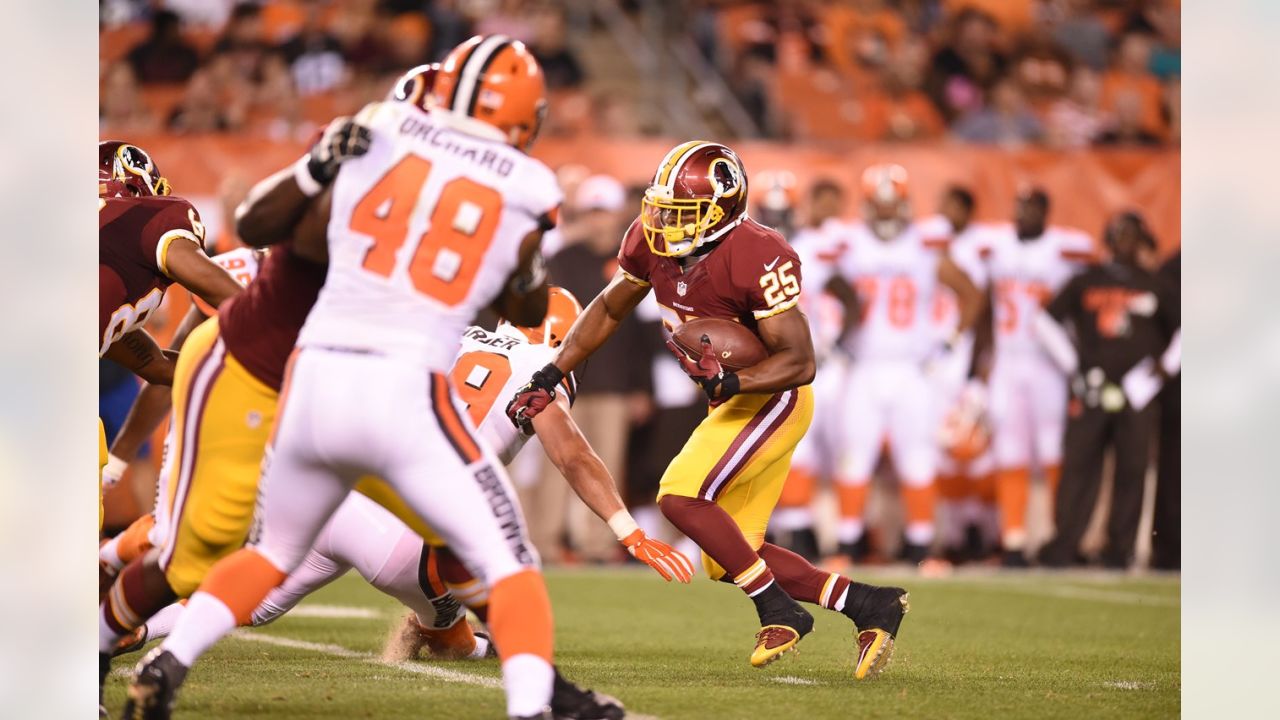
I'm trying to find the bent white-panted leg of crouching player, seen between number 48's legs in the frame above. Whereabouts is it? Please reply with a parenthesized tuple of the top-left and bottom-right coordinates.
(316, 492, 466, 628)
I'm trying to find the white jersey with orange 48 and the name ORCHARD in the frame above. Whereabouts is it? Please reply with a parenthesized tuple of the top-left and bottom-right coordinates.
(298, 102, 562, 372)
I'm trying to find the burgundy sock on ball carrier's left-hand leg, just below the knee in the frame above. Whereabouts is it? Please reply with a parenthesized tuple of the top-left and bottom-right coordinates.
(658, 495, 757, 586)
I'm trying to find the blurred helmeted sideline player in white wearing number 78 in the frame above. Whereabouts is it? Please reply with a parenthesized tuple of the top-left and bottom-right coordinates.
(828, 165, 982, 562)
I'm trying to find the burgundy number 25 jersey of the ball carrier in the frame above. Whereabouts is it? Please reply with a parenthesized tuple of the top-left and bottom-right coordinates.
(618, 218, 800, 334)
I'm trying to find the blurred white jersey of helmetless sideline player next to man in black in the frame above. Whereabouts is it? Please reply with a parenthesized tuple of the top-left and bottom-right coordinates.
(982, 225, 1094, 355)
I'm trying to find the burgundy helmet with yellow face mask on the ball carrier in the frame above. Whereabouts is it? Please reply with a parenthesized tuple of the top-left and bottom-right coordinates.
(640, 140, 748, 258)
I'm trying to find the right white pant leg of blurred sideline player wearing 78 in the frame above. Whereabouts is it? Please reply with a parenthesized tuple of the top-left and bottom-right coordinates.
(884, 364, 938, 487)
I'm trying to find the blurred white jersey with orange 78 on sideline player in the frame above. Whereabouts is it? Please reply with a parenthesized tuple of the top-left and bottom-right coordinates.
(831, 223, 941, 363)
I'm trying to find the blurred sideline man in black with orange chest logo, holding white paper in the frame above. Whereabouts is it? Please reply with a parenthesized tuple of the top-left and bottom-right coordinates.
(1034, 213, 1181, 569)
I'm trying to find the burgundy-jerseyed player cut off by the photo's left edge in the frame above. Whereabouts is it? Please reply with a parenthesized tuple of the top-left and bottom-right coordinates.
(97, 140, 239, 530)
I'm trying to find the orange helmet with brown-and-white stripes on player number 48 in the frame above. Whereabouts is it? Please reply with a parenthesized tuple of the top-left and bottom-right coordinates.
(428, 35, 547, 150)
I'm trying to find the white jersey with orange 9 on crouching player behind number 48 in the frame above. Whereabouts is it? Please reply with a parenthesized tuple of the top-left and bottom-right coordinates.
(451, 325, 577, 464)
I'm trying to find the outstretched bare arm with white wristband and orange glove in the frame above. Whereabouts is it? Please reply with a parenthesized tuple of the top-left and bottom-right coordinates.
(532, 396, 694, 583)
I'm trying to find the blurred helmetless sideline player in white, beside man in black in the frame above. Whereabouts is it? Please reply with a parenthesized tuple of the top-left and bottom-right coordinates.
(982, 188, 1097, 566)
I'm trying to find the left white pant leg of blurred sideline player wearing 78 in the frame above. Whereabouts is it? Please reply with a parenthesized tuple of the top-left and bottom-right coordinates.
(836, 363, 888, 484)
